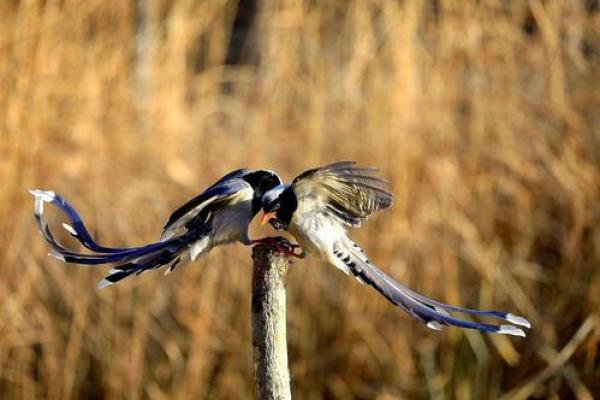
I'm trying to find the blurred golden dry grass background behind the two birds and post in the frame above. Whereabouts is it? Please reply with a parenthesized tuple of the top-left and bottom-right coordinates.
(0, 0, 600, 399)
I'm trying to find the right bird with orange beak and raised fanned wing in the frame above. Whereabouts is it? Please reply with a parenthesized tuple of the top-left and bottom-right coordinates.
(261, 161, 531, 336)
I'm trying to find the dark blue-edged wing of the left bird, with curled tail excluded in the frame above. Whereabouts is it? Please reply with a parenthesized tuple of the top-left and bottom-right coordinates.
(161, 177, 253, 240)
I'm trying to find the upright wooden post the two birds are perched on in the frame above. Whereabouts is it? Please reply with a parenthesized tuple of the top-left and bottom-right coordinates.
(252, 244, 292, 400)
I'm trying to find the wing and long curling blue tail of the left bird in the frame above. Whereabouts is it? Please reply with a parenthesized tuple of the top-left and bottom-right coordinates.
(30, 170, 252, 288)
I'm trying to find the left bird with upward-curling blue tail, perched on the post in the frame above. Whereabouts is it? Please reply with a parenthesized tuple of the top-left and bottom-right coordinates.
(30, 169, 281, 288)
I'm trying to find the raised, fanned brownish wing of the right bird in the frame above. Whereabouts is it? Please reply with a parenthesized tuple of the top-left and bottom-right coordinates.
(292, 161, 392, 226)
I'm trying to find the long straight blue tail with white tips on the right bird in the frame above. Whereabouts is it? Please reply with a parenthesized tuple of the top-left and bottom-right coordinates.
(334, 244, 531, 336)
